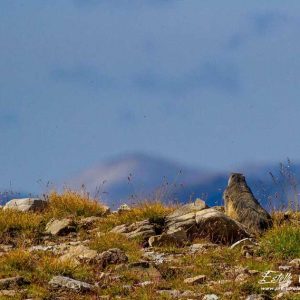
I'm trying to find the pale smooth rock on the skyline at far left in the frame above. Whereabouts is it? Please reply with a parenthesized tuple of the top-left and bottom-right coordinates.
(3, 198, 48, 212)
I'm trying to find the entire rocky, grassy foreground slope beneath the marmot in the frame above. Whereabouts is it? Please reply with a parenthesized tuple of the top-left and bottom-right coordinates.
(0, 191, 300, 300)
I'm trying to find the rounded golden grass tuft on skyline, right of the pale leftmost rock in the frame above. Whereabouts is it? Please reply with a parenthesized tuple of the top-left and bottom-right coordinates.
(46, 190, 105, 218)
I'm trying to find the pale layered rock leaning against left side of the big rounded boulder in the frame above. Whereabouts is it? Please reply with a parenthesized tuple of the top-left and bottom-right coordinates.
(166, 199, 208, 234)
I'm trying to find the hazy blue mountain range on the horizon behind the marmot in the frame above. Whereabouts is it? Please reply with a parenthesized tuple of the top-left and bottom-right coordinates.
(68, 154, 300, 207)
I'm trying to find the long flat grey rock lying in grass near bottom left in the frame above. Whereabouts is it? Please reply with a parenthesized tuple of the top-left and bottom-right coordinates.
(49, 276, 94, 292)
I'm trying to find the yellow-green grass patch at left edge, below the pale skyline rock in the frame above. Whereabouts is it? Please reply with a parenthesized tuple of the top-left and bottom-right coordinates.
(0, 209, 43, 243)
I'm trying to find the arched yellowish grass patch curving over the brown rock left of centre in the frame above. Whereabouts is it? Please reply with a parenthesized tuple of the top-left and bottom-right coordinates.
(90, 232, 141, 261)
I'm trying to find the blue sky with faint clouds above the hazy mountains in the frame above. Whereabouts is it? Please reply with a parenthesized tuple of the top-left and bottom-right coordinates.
(0, 0, 300, 191)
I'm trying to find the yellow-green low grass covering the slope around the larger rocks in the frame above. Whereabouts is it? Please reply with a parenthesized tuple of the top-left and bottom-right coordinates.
(0, 191, 300, 300)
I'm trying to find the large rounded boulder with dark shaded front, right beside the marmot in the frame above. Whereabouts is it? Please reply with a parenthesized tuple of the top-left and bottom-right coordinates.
(194, 208, 249, 244)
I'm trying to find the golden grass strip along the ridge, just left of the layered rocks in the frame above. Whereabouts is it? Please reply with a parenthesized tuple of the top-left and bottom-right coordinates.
(100, 201, 175, 230)
